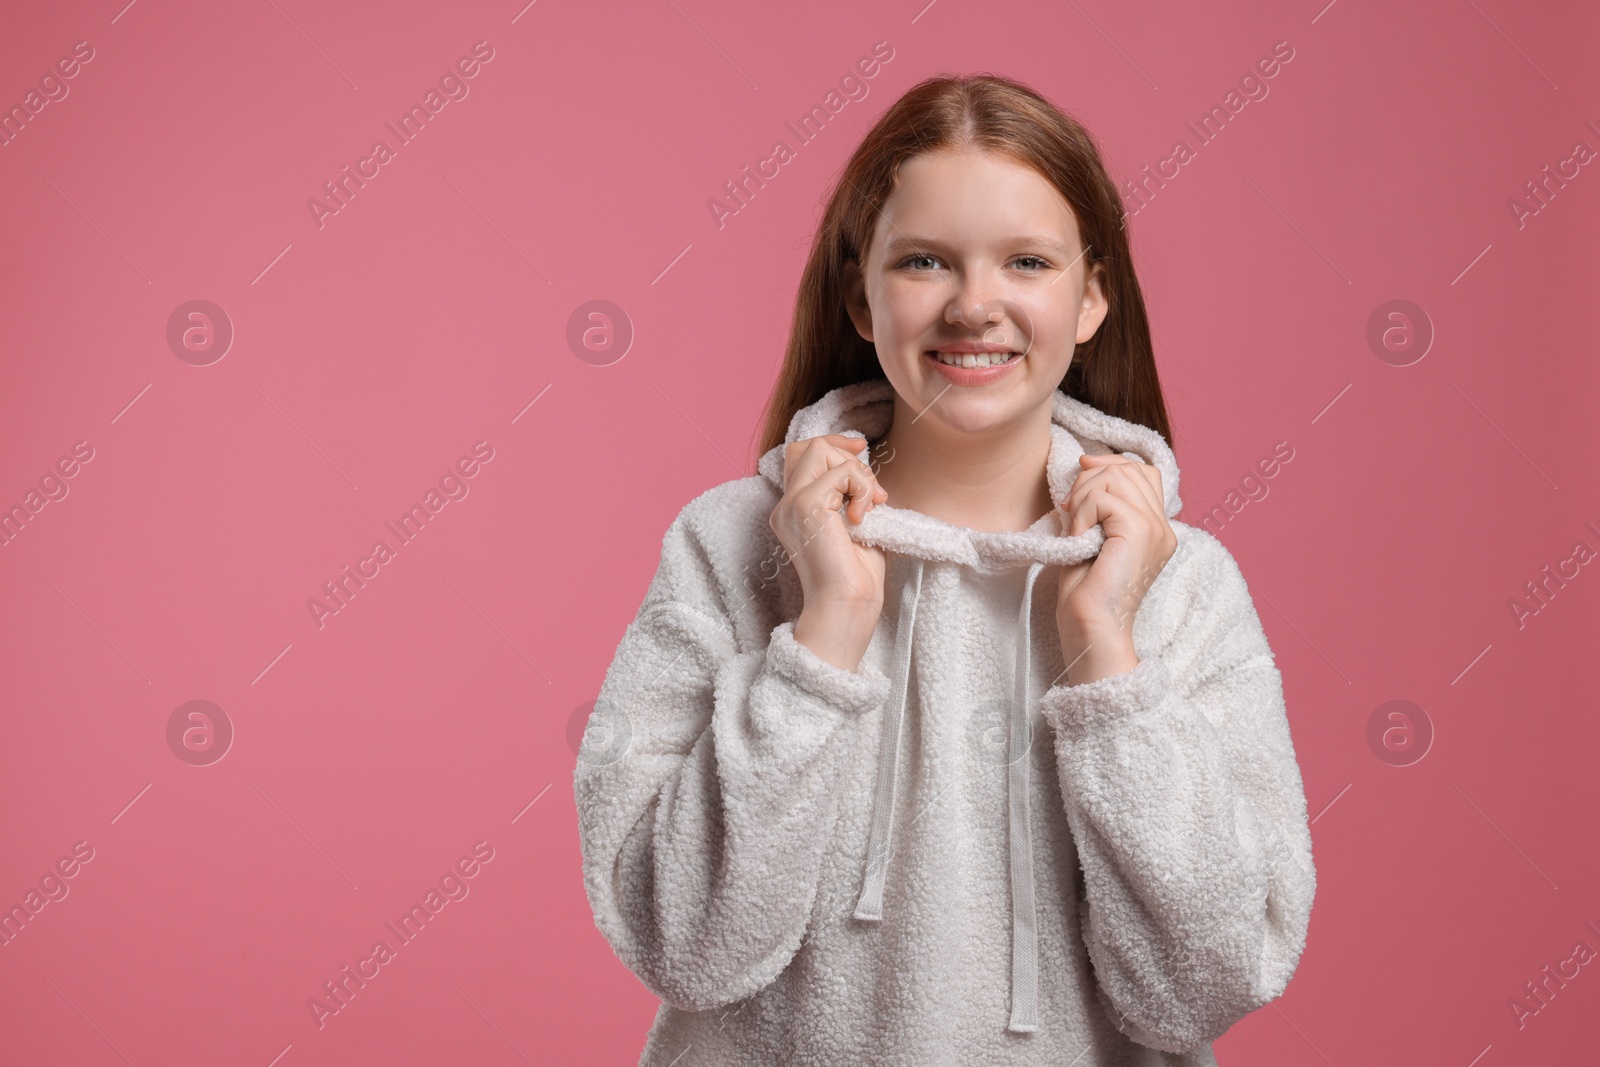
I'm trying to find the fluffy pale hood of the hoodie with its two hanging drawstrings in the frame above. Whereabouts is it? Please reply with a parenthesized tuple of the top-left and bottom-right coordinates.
(757, 378, 1182, 1033)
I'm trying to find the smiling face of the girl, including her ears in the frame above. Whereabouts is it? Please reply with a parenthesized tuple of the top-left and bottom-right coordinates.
(846, 150, 1107, 434)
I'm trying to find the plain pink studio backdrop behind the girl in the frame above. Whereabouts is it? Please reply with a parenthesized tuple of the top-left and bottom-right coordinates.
(0, 0, 1600, 1067)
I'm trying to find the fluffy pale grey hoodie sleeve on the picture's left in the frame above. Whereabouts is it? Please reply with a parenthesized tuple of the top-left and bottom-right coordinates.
(574, 495, 890, 1011)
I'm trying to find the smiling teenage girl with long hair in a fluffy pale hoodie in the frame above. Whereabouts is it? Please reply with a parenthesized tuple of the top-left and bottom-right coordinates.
(574, 75, 1315, 1067)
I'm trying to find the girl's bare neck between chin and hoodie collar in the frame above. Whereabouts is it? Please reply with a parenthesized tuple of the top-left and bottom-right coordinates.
(877, 397, 1054, 531)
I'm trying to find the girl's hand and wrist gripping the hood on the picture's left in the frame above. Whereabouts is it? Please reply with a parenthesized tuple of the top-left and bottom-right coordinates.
(768, 434, 888, 670)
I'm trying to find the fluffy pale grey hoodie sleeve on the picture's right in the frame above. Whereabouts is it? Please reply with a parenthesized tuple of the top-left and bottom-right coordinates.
(1043, 531, 1317, 1053)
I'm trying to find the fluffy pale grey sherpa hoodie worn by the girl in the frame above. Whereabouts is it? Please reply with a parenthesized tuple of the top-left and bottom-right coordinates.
(574, 379, 1315, 1067)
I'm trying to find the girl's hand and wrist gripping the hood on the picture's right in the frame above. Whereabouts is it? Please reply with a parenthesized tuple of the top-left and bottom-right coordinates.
(1056, 454, 1178, 685)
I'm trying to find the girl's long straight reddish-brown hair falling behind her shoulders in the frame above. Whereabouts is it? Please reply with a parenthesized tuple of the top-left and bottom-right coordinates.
(758, 74, 1173, 454)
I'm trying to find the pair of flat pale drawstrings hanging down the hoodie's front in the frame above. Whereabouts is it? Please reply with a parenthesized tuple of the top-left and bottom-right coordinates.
(854, 558, 1045, 1033)
